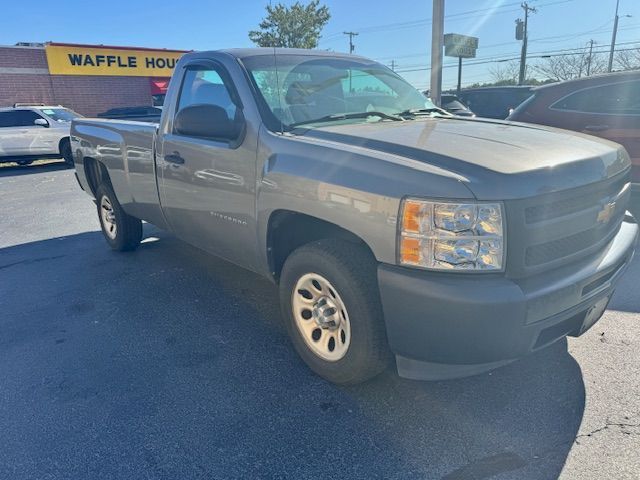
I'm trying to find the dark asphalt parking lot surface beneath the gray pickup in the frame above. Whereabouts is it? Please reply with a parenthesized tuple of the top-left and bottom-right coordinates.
(0, 164, 640, 480)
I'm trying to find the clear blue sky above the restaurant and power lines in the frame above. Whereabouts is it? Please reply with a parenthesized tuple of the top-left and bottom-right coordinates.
(0, 0, 640, 89)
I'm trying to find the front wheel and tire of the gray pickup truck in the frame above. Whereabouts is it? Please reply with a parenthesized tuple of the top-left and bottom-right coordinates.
(280, 239, 391, 384)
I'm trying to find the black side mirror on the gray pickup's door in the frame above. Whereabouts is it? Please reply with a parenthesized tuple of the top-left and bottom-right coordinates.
(173, 104, 241, 141)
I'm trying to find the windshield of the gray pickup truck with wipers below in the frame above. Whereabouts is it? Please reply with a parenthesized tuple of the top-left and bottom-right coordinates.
(243, 55, 436, 130)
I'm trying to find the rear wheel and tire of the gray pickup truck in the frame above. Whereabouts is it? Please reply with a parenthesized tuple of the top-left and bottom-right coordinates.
(96, 183, 142, 252)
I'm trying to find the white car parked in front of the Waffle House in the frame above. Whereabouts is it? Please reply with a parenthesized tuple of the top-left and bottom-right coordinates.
(0, 103, 81, 165)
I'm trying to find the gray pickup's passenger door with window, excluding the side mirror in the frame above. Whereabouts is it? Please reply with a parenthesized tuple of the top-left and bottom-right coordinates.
(156, 61, 257, 268)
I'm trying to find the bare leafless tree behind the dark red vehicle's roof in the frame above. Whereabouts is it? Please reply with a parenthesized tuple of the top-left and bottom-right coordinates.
(533, 44, 607, 80)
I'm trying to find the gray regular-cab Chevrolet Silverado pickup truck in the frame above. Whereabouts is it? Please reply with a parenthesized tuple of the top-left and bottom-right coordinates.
(71, 49, 638, 383)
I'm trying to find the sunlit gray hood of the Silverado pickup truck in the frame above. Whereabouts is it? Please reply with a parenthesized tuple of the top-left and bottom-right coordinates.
(300, 118, 630, 200)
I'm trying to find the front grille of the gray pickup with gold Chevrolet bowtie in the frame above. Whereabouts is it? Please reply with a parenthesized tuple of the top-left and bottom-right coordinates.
(506, 173, 630, 277)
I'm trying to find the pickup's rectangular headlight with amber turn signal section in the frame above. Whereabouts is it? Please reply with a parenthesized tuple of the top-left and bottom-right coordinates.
(398, 199, 504, 271)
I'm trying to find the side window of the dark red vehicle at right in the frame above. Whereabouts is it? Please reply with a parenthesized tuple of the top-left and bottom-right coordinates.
(551, 82, 640, 115)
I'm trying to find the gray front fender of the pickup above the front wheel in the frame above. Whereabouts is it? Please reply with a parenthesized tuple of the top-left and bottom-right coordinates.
(256, 130, 473, 263)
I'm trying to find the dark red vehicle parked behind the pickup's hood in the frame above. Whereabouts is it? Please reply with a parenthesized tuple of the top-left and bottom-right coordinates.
(508, 71, 640, 204)
